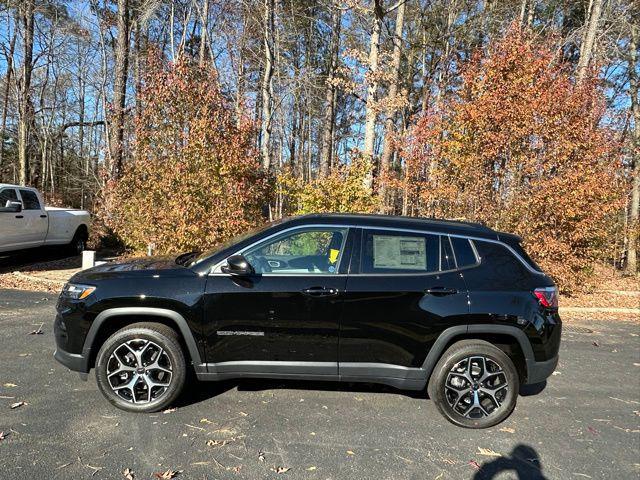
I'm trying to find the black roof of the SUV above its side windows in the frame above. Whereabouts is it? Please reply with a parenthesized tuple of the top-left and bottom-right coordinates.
(283, 213, 498, 238)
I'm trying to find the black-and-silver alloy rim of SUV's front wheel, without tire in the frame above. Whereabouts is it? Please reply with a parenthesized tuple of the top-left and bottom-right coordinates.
(107, 338, 173, 404)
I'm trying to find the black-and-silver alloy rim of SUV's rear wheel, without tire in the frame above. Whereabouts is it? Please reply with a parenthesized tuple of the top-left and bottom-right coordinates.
(444, 355, 509, 419)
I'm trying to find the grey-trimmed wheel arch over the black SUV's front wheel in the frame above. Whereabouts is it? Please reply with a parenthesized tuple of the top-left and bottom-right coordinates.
(83, 307, 204, 372)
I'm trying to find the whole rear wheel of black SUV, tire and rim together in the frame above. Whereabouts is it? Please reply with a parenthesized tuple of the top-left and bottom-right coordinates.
(428, 340, 520, 428)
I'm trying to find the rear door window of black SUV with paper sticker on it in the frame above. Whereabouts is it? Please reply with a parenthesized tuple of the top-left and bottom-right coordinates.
(361, 230, 440, 273)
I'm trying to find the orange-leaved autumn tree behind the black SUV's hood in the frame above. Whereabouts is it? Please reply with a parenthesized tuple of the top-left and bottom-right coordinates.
(105, 56, 268, 253)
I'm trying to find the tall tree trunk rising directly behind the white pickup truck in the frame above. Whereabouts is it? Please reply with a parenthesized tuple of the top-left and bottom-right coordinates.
(18, 0, 35, 185)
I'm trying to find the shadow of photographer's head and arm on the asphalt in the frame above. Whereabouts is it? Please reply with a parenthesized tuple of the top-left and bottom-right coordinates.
(473, 444, 547, 480)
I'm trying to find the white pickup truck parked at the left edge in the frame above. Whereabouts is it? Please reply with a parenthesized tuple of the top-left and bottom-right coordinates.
(0, 183, 90, 254)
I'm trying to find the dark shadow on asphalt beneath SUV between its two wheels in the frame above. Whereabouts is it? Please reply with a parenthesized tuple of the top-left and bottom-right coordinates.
(175, 378, 428, 407)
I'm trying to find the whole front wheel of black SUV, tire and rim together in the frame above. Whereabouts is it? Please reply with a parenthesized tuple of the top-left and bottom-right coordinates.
(95, 323, 187, 412)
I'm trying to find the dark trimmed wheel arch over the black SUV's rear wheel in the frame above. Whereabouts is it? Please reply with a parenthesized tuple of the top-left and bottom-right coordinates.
(422, 325, 535, 383)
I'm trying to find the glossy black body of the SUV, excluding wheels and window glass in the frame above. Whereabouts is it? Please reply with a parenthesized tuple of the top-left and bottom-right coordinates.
(54, 215, 561, 389)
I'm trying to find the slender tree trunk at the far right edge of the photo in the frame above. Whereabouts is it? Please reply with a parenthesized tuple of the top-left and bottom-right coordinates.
(627, 25, 640, 274)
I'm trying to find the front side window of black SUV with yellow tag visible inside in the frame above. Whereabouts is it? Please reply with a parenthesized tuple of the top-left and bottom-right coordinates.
(244, 228, 347, 275)
